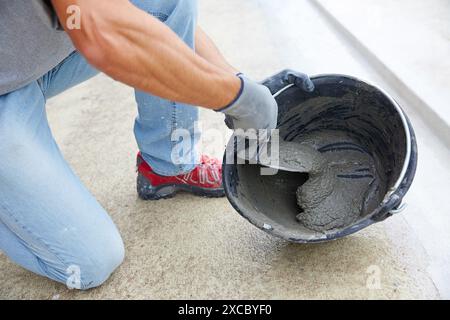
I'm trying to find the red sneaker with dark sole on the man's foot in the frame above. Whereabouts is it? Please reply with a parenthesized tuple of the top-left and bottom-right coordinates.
(137, 153, 225, 200)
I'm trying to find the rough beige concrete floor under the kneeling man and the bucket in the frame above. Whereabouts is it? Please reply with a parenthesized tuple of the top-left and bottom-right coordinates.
(0, 0, 450, 299)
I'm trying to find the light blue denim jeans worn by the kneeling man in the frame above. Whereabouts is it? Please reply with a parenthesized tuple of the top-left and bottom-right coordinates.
(0, 0, 199, 289)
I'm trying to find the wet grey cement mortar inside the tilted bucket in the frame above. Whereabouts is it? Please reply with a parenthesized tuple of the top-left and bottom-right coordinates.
(280, 131, 381, 232)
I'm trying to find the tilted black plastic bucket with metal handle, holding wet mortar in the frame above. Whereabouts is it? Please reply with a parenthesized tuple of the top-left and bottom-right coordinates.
(223, 74, 417, 243)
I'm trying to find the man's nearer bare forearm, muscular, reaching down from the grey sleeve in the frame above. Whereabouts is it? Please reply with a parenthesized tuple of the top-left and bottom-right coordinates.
(52, 0, 241, 109)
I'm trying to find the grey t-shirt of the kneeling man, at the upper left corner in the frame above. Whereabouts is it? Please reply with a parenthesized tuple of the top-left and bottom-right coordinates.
(0, 0, 75, 95)
